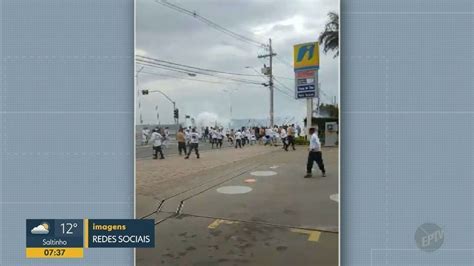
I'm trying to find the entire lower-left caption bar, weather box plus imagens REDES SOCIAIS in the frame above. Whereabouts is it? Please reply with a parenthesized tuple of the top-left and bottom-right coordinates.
(26, 219, 155, 259)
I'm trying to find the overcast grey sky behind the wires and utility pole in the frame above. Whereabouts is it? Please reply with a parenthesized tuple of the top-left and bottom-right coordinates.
(136, 0, 339, 123)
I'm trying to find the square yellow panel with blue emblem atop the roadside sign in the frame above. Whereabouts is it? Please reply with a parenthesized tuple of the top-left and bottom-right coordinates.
(293, 42, 319, 71)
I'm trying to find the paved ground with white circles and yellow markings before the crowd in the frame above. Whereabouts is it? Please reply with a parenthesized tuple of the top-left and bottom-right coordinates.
(137, 146, 338, 266)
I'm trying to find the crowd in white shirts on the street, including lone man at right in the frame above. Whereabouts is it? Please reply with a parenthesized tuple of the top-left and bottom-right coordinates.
(142, 125, 326, 178)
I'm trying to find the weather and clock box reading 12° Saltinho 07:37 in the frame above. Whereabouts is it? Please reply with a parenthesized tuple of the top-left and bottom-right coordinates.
(26, 219, 84, 258)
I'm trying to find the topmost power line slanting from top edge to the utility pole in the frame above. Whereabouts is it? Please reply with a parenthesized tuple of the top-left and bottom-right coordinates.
(155, 0, 266, 47)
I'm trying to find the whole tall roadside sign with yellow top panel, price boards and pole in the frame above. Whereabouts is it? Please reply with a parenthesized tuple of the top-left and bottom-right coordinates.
(293, 42, 319, 135)
